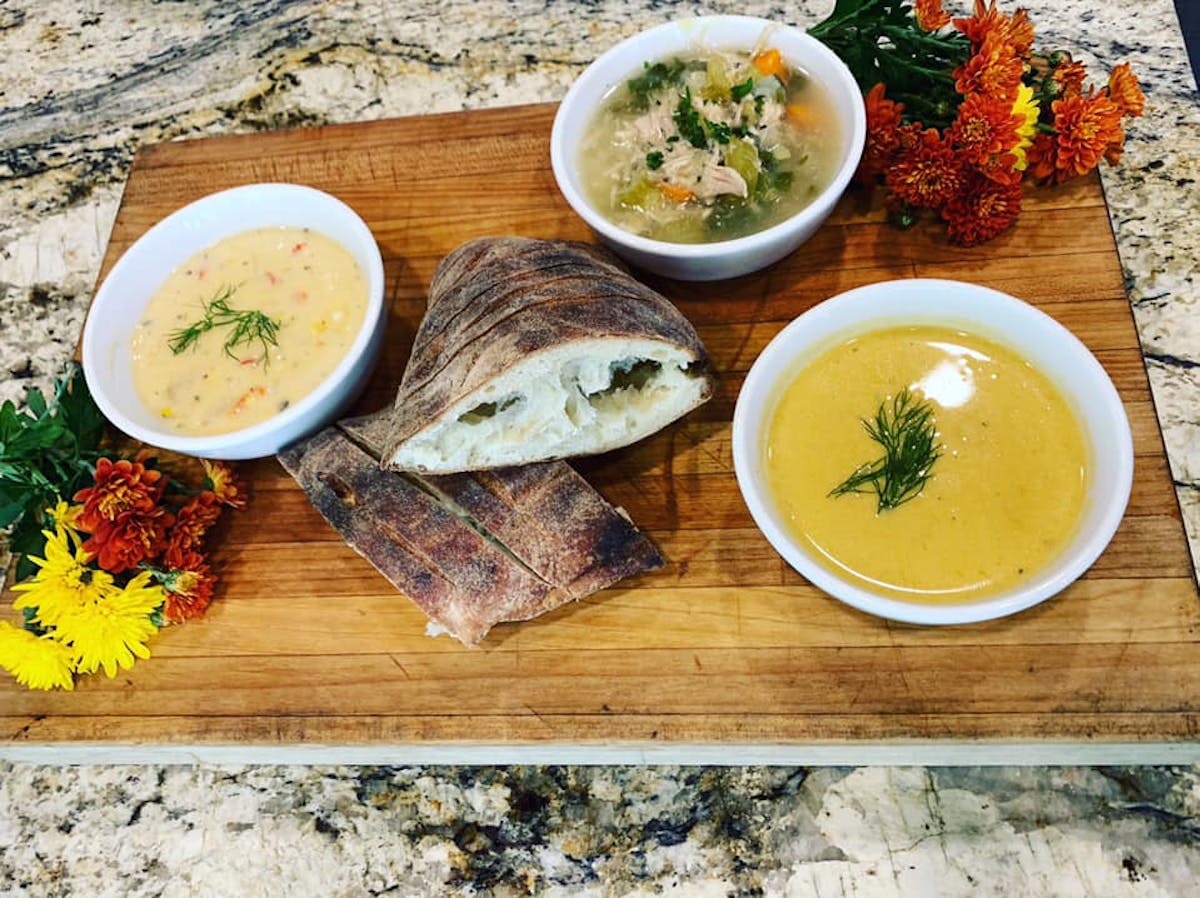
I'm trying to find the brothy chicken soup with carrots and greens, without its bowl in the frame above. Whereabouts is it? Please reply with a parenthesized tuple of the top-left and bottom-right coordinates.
(580, 48, 840, 244)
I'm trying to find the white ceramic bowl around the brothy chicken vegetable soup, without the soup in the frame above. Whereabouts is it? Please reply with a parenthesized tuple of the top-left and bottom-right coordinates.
(550, 16, 866, 281)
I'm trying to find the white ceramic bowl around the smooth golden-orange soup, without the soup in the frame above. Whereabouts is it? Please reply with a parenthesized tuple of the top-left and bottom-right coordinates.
(733, 279, 1133, 624)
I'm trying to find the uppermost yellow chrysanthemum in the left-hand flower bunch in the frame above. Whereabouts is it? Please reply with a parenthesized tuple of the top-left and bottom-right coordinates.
(12, 519, 113, 627)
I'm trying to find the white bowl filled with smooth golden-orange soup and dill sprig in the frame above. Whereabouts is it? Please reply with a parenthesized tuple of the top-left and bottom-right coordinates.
(733, 279, 1133, 624)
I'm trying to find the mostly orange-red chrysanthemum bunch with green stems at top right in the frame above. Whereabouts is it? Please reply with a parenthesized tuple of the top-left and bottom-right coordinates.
(809, 0, 1145, 246)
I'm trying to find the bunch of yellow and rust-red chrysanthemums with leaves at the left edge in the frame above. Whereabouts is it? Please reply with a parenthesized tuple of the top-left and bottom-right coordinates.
(0, 365, 246, 689)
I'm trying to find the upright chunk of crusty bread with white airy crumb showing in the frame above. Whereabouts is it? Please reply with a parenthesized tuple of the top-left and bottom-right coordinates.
(382, 237, 713, 474)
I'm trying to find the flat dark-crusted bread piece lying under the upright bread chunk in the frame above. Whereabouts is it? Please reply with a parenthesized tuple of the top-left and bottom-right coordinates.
(278, 412, 664, 646)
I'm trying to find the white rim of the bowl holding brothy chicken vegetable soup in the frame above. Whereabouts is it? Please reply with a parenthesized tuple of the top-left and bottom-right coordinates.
(550, 14, 866, 259)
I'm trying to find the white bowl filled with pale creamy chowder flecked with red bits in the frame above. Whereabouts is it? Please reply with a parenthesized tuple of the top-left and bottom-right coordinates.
(82, 184, 386, 460)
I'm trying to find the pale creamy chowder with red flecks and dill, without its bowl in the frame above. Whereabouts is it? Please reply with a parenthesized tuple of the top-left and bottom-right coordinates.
(131, 227, 367, 436)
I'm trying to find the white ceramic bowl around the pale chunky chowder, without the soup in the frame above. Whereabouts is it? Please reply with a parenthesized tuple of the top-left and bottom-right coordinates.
(82, 184, 386, 460)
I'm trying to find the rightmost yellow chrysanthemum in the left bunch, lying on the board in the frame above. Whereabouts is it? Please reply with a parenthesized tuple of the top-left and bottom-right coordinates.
(55, 570, 167, 678)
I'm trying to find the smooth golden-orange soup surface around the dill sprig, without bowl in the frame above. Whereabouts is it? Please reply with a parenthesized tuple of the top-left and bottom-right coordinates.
(766, 327, 1088, 603)
